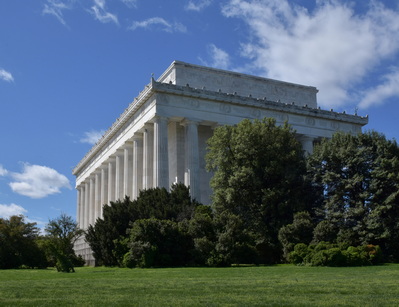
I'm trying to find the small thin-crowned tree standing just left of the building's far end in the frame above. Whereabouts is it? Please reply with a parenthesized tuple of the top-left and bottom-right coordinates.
(45, 213, 83, 272)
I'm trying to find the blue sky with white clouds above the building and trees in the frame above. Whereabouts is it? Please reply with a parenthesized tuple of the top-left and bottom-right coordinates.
(0, 0, 399, 231)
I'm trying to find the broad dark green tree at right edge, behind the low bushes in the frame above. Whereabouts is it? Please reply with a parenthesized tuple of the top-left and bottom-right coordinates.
(308, 131, 399, 260)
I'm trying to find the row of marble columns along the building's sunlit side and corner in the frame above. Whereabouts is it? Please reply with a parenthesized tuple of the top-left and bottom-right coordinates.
(76, 116, 200, 229)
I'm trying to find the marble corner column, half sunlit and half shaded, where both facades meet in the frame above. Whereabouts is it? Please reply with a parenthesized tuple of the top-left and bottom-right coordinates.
(153, 116, 169, 189)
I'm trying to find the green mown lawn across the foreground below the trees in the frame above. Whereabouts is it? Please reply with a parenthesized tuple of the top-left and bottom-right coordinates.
(0, 264, 399, 306)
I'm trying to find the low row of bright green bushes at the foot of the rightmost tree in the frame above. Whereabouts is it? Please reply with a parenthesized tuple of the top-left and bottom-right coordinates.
(289, 242, 383, 267)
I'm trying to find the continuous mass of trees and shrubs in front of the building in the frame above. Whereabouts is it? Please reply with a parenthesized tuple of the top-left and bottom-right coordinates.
(86, 119, 399, 267)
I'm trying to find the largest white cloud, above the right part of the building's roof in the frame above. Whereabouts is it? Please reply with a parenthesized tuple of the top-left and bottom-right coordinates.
(222, 0, 399, 107)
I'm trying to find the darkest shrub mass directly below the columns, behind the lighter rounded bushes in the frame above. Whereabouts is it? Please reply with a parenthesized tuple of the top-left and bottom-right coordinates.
(86, 184, 198, 266)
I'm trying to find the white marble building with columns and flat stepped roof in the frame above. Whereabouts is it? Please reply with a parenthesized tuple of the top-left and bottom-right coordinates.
(73, 61, 368, 264)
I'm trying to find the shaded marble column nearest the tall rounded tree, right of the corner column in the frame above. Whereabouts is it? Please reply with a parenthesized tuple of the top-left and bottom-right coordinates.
(183, 120, 201, 201)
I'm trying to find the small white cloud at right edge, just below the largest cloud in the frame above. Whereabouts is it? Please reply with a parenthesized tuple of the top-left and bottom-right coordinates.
(359, 68, 399, 108)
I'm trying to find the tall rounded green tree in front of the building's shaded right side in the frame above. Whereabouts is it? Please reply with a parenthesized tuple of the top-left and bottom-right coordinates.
(206, 119, 315, 263)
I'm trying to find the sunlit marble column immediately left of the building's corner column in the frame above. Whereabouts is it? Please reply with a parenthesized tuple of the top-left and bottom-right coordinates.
(143, 124, 154, 189)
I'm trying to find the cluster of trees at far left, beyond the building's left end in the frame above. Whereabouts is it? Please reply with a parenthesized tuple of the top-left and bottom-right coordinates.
(0, 214, 84, 272)
